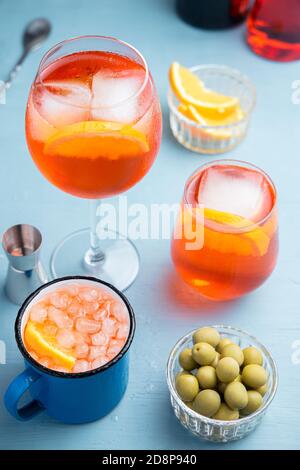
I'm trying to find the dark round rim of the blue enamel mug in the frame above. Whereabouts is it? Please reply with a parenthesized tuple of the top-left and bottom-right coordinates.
(15, 276, 136, 379)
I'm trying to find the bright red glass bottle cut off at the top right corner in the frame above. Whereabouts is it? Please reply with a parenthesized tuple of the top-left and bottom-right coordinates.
(247, 0, 300, 62)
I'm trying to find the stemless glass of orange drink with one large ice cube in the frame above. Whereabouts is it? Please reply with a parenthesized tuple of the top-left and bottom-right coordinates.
(172, 160, 278, 300)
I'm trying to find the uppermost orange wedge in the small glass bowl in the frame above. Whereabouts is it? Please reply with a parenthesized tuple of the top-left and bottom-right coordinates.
(169, 62, 238, 119)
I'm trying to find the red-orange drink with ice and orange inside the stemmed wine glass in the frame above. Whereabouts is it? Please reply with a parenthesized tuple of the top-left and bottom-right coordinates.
(26, 51, 161, 198)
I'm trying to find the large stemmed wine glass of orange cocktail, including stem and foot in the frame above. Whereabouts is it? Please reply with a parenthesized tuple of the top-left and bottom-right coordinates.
(26, 36, 162, 290)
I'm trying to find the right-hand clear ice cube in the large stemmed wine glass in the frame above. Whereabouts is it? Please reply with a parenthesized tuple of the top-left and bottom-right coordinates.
(91, 71, 145, 123)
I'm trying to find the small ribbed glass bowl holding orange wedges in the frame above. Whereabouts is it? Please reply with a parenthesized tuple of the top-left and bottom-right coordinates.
(168, 62, 256, 154)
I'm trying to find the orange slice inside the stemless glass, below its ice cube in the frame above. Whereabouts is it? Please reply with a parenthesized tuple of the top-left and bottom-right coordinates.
(204, 208, 270, 256)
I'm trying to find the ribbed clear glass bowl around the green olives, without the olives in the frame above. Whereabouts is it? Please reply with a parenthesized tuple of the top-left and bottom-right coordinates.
(167, 325, 278, 442)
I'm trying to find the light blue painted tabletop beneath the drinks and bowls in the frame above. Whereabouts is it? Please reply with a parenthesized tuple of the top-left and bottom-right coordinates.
(0, 0, 300, 449)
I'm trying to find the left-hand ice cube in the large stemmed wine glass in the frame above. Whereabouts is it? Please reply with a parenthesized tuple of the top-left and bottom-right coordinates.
(34, 79, 91, 128)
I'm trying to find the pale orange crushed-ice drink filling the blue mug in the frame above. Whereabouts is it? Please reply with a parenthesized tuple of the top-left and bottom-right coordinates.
(24, 281, 130, 372)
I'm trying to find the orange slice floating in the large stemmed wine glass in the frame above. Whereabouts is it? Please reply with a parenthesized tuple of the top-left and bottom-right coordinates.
(44, 121, 149, 159)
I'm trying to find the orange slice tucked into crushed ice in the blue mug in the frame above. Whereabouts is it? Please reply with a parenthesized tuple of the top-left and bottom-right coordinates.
(24, 320, 76, 370)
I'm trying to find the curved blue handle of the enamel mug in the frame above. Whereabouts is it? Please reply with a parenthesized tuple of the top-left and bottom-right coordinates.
(4, 368, 44, 421)
